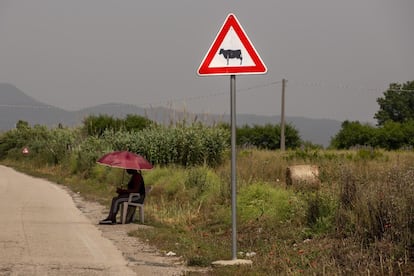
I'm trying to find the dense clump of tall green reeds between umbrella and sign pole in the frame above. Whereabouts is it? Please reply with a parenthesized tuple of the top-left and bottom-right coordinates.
(102, 124, 228, 166)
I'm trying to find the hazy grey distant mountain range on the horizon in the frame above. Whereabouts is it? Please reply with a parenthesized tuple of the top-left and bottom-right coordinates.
(0, 83, 341, 147)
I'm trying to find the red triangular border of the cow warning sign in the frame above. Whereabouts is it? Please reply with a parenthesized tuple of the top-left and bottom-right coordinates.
(197, 13, 267, 76)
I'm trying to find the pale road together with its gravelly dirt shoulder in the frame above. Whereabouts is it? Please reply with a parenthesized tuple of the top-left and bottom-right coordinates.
(0, 166, 204, 275)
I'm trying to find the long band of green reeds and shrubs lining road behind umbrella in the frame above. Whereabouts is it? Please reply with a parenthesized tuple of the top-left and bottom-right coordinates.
(0, 123, 229, 178)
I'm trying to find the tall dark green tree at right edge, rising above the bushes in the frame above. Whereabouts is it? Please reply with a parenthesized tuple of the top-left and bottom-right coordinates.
(374, 81, 414, 126)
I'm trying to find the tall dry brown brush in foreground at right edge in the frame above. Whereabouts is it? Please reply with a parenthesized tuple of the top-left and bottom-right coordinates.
(337, 167, 414, 258)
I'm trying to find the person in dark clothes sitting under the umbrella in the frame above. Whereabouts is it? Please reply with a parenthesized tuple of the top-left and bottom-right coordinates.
(99, 169, 145, 224)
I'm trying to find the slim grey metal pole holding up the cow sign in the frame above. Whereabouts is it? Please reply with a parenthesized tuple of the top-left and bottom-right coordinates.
(230, 75, 237, 260)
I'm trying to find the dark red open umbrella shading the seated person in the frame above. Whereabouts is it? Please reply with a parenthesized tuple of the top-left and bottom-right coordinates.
(97, 151, 152, 170)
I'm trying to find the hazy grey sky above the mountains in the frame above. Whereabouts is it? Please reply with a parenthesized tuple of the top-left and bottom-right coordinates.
(0, 0, 414, 122)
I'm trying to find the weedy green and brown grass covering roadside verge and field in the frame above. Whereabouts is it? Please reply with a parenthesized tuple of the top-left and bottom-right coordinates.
(1, 149, 414, 275)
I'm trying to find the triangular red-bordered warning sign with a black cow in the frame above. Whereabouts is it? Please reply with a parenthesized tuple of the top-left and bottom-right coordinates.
(197, 14, 267, 76)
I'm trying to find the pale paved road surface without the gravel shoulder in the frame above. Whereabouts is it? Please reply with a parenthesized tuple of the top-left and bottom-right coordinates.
(0, 166, 136, 275)
